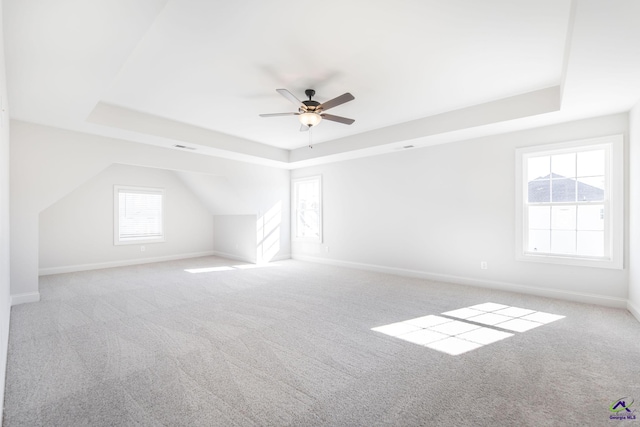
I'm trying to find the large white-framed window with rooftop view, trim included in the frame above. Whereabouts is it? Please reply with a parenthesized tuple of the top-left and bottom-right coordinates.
(517, 136, 623, 268)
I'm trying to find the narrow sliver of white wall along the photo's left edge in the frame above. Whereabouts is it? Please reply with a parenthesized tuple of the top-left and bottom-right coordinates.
(0, 3, 11, 418)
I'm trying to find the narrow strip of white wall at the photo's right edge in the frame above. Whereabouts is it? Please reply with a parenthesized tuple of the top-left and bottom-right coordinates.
(628, 102, 640, 321)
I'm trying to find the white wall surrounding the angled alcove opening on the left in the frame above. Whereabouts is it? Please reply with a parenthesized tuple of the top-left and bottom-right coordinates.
(10, 121, 290, 303)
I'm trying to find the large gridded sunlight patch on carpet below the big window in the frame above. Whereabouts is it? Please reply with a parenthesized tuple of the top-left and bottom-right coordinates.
(371, 302, 564, 356)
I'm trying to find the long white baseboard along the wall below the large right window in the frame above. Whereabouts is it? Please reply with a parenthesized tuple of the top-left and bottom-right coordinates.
(291, 255, 637, 310)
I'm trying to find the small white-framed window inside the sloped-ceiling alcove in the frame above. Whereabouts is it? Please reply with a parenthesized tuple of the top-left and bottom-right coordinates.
(114, 185, 164, 245)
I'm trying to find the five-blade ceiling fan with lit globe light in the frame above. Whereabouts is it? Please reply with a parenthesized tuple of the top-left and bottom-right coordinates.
(260, 89, 355, 132)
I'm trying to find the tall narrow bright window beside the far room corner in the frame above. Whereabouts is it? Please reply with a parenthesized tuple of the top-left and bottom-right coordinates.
(293, 176, 322, 242)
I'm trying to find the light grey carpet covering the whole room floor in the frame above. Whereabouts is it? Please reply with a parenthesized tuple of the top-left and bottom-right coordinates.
(4, 257, 640, 426)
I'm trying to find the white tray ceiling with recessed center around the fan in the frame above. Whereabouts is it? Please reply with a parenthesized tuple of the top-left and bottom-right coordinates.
(3, 0, 640, 167)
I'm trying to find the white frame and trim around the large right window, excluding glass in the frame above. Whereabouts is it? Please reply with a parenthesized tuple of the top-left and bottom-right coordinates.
(515, 135, 624, 269)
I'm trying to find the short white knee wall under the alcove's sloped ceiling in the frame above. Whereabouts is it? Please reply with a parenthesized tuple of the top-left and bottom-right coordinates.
(213, 215, 257, 262)
